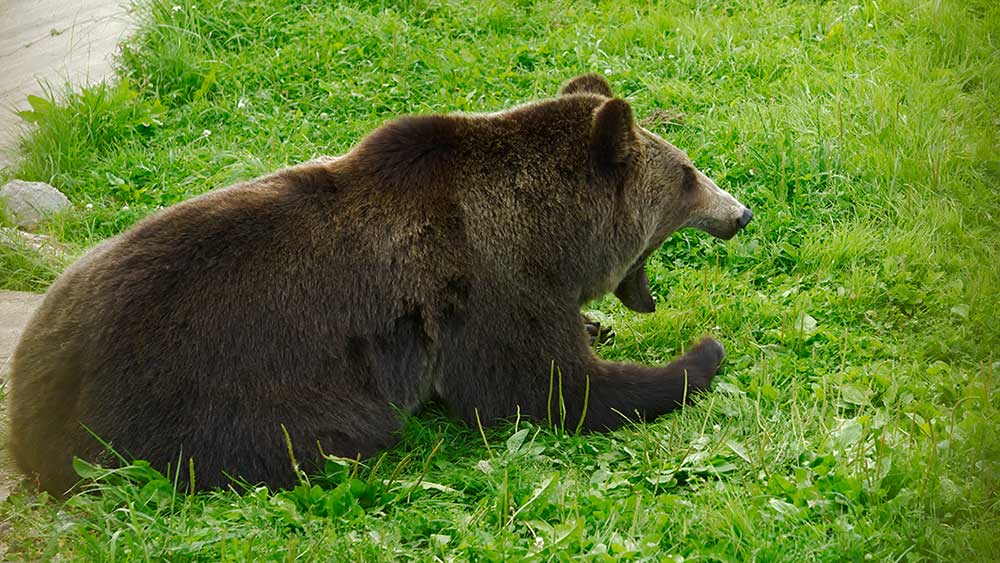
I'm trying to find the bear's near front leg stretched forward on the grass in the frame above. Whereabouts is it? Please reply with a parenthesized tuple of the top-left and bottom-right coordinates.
(437, 307, 725, 430)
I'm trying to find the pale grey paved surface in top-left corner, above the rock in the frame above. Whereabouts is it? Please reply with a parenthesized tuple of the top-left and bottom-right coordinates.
(0, 0, 131, 167)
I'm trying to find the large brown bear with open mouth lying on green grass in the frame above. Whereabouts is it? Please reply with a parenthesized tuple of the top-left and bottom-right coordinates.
(10, 75, 751, 494)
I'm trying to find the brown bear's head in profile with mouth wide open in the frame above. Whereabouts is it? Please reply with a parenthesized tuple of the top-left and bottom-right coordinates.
(560, 74, 753, 313)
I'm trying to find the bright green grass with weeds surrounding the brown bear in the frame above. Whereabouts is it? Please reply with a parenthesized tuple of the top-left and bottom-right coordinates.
(0, 0, 1000, 561)
